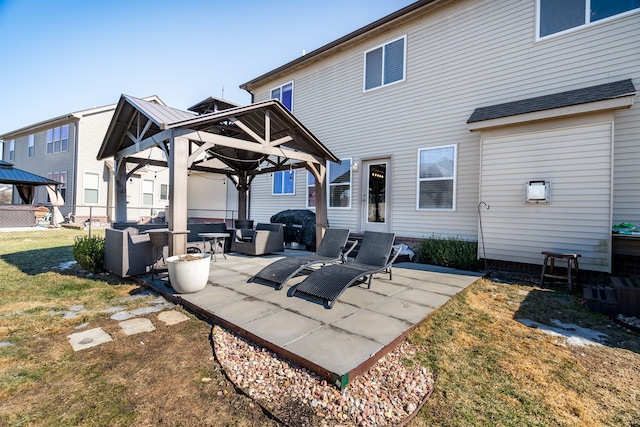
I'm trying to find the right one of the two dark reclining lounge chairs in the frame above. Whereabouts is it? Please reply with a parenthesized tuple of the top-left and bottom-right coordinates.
(291, 231, 400, 308)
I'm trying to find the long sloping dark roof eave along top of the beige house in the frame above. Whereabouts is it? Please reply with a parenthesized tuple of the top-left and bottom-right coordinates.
(240, 0, 442, 92)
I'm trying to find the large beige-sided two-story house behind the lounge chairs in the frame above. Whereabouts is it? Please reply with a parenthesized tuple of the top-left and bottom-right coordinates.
(241, 0, 640, 272)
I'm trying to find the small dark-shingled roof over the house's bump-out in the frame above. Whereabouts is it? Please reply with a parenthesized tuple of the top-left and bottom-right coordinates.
(467, 79, 636, 123)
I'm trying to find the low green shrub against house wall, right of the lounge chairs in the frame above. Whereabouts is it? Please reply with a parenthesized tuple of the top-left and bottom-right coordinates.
(416, 236, 482, 270)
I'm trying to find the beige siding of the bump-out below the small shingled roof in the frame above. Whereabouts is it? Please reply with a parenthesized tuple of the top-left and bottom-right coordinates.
(481, 123, 612, 271)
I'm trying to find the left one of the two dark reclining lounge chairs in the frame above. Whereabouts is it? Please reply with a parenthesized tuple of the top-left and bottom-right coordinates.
(248, 228, 355, 290)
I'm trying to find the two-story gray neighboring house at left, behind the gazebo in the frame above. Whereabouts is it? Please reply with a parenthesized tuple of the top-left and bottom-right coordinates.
(0, 96, 169, 223)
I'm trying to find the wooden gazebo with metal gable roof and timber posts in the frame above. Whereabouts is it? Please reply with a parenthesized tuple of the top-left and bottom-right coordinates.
(97, 95, 340, 255)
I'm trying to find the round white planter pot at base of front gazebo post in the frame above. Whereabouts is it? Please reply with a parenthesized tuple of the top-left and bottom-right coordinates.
(166, 254, 211, 294)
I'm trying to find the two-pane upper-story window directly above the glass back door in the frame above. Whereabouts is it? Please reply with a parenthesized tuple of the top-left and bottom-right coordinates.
(364, 36, 407, 91)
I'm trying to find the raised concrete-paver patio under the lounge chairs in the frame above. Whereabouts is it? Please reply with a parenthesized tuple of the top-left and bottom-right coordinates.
(141, 250, 481, 388)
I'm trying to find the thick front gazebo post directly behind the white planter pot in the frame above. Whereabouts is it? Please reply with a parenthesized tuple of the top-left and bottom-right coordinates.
(169, 136, 189, 256)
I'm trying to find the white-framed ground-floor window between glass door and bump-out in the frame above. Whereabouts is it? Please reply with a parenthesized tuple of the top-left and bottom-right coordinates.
(417, 145, 458, 211)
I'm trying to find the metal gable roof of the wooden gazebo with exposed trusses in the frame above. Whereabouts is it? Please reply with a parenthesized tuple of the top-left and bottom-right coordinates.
(97, 95, 340, 175)
